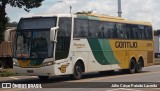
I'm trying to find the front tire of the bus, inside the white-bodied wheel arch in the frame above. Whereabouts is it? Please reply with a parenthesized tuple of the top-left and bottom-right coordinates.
(72, 62, 82, 80)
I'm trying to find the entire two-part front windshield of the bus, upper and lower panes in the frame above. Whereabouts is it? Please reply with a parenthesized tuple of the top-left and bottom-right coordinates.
(14, 18, 56, 58)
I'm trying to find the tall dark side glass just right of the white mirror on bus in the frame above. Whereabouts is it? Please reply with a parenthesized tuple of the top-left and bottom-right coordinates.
(55, 17, 71, 60)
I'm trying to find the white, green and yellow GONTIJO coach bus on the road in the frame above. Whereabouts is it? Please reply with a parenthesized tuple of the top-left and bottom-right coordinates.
(7, 14, 154, 80)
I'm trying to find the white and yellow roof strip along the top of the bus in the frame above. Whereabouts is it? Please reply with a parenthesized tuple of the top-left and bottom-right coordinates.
(22, 14, 152, 26)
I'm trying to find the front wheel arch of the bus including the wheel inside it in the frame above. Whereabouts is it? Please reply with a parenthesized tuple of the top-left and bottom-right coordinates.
(72, 59, 85, 80)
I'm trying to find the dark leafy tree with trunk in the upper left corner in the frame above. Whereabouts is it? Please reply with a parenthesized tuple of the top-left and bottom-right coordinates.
(0, 0, 44, 43)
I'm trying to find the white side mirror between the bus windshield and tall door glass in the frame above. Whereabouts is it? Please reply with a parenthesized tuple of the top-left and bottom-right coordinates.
(50, 27, 59, 42)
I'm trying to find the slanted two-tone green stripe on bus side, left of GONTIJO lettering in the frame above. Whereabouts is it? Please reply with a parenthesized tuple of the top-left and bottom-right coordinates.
(88, 38, 118, 65)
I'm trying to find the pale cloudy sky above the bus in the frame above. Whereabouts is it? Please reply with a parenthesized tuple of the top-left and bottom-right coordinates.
(6, 0, 160, 30)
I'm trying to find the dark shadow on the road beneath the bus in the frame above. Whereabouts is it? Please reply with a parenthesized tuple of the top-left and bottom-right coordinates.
(0, 71, 149, 84)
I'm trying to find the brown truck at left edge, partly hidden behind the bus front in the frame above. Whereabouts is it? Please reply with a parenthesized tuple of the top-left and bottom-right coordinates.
(0, 27, 16, 69)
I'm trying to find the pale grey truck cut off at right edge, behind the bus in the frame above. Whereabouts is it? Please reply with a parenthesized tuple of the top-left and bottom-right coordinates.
(154, 36, 160, 58)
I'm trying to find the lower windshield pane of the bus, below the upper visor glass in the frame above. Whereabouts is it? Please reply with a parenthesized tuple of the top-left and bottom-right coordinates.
(15, 31, 53, 58)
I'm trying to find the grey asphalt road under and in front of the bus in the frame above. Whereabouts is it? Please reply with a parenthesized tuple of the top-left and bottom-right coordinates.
(0, 65, 160, 91)
